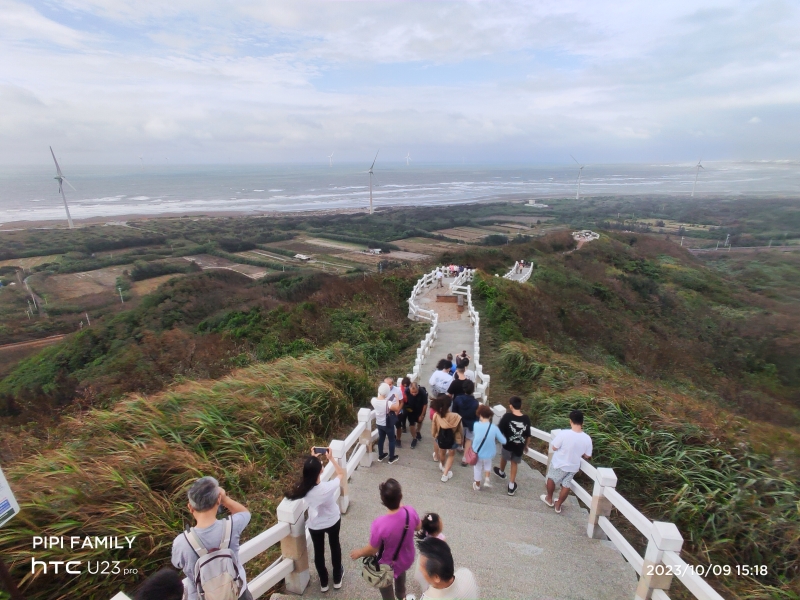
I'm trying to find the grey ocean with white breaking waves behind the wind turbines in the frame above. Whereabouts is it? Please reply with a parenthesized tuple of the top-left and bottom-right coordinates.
(0, 161, 800, 223)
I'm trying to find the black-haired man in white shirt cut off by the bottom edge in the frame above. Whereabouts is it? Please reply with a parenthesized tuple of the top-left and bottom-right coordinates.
(417, 536, 480, 600)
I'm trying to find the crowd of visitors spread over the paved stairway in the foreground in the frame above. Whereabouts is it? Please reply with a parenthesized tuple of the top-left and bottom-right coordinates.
(123, 360, 592, 600)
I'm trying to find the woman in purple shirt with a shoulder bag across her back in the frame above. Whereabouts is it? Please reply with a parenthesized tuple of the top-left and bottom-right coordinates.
(350, 479, 422, 600)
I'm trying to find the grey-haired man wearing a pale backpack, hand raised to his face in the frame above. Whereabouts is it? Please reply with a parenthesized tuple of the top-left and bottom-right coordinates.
(172, 477, 253, 600)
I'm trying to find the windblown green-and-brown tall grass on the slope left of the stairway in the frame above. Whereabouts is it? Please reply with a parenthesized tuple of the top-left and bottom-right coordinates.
(0, 345, 372, 600)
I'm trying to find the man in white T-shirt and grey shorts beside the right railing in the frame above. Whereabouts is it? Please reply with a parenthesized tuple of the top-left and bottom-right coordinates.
(540, 410, 592, 513)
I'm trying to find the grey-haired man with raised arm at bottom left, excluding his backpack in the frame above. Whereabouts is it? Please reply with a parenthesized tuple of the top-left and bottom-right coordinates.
(172, 477, 253, 600)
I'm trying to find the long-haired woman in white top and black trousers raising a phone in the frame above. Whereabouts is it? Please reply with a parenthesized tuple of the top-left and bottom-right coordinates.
(285, 448, 347, 592)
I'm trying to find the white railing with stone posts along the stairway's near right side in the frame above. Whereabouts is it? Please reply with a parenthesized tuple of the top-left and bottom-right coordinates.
(504, 422, 723, 600)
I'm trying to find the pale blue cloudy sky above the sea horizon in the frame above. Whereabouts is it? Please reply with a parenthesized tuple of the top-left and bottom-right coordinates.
(0, 0, 800, 165)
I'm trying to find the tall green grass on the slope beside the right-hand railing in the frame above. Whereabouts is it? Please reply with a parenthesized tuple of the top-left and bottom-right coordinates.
(501, 343, 800, 598)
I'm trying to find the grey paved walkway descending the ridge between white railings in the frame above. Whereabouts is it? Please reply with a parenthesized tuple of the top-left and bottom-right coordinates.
(304, 276, 636, 600)
